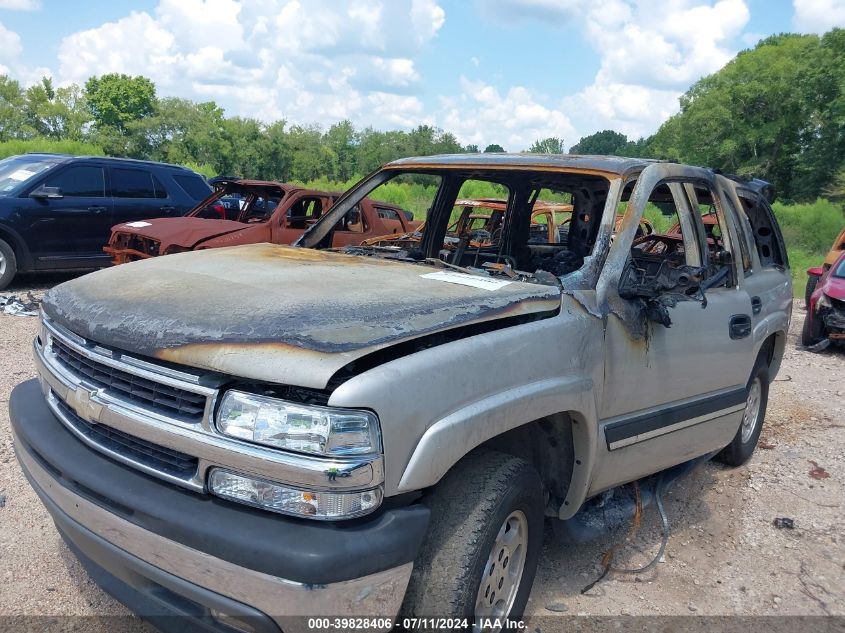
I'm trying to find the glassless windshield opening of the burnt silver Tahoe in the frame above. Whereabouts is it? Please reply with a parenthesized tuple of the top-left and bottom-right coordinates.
(303, 168, 610, 284)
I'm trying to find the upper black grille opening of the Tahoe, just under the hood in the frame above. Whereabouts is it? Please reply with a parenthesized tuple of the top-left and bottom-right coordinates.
(52, 337, 206, 422)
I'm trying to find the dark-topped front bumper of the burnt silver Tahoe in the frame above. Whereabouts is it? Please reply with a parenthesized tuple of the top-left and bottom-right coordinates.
(9, 380, 429, 632)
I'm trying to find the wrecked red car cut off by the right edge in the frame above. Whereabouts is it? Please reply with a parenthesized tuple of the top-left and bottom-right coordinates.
(801, 252, 845, 348)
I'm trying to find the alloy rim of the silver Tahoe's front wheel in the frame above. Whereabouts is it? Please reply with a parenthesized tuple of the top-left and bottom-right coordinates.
(475, 510, 528, 631)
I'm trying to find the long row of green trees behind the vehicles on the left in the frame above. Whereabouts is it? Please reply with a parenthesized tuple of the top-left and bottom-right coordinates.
(0, 74, 536, 182)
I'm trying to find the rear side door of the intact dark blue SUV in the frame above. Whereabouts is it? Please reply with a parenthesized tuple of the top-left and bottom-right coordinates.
(109, 166, 178, 224)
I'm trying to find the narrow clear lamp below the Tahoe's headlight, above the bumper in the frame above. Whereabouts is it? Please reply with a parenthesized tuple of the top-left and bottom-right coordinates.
(208, 468, 382, 520)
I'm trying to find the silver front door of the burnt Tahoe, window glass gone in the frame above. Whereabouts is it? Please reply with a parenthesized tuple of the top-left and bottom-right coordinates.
(593, 164, 753, 490)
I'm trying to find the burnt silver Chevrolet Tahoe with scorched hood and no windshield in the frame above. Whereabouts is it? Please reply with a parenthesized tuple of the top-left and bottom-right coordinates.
(9, 154, 792, 631)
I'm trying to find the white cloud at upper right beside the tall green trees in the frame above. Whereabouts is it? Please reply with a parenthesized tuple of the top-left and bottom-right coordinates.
(464, 0, 750, 147)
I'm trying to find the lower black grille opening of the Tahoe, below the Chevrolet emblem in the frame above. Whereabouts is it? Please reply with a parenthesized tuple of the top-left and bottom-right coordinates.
(55, 398, 199, 479)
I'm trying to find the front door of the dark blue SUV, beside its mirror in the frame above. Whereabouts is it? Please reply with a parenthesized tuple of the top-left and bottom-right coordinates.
(24, 163, 113, 269)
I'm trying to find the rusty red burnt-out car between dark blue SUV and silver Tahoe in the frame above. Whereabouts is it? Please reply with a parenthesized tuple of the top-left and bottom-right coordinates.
(103, 179, 420, 264)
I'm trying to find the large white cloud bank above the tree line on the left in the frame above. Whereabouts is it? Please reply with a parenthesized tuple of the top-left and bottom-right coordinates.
(52, 0, 445, 127)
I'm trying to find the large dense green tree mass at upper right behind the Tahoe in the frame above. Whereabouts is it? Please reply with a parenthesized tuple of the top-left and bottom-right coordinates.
(649, 29, 845, 200)
